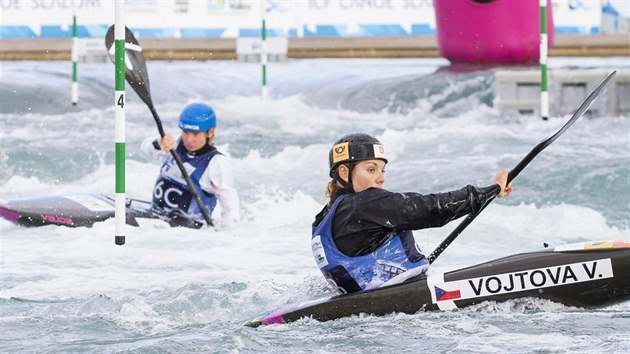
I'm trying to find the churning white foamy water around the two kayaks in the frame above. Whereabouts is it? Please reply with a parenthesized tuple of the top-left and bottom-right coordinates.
(0, 59, 630, 352)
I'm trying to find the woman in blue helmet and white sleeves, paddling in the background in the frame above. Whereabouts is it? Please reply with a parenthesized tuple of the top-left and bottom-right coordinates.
(142, 103, 240, 228)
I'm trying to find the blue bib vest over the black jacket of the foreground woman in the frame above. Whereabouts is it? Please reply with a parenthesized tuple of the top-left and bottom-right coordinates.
(311, 195, 429, 293)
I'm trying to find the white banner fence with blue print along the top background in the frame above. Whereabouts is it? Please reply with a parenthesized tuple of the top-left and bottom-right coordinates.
(0, 0, 630, 38)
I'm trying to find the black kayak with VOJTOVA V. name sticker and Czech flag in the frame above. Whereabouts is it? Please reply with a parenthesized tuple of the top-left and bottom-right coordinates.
(244, 240, 630, 327)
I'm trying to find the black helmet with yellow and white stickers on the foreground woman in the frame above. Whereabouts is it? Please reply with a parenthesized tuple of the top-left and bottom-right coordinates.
(328, 133, 387, 177)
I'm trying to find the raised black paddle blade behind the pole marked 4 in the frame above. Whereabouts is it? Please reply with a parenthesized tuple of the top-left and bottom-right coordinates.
(105, 25, 153, 107)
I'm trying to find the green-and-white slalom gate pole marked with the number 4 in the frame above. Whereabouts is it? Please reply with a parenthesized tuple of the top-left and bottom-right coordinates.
(114, 0, 126, 245)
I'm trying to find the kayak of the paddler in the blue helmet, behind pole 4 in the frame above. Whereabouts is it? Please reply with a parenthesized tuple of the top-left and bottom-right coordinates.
(0, 194, 157, 227)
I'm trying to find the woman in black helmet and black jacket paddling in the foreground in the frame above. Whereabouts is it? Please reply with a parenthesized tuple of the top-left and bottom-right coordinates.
(311, 133, 512, 293)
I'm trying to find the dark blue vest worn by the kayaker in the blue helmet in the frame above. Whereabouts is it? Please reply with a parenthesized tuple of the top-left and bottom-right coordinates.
(152, 141, 220, 220)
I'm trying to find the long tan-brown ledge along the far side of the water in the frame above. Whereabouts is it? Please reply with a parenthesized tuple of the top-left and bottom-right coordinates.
(0, 34, 630, 60)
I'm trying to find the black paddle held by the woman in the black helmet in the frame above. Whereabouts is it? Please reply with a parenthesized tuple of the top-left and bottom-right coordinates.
(428, 71, 617, 264)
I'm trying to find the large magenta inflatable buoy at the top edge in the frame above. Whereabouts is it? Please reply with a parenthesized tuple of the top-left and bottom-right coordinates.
(433, 0, 553, 64)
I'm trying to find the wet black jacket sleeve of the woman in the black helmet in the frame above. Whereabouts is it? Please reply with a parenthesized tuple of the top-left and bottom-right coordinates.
(333, 184, 501, 255)
